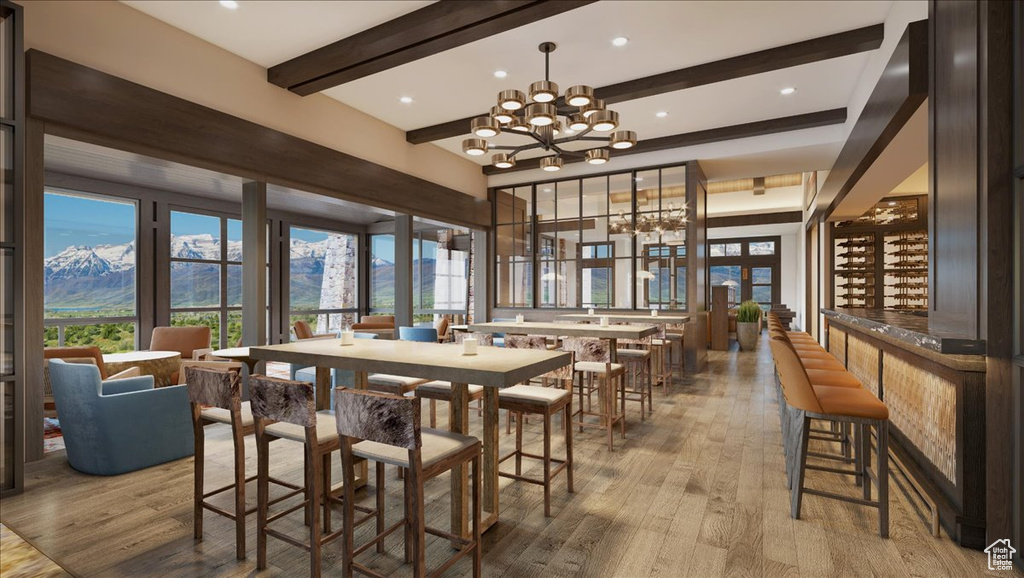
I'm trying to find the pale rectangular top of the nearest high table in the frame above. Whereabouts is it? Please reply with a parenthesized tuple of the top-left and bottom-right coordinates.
(250, 339, 571, 387)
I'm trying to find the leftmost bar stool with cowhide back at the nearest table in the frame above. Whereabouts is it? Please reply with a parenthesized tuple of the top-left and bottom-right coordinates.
(185, 361, 302, 560)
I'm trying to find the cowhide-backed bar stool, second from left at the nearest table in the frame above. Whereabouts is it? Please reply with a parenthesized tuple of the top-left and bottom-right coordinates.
(249, 375, 374, 578)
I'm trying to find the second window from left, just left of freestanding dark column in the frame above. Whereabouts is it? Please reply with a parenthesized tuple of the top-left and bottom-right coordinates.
(171, 210, 242, 347)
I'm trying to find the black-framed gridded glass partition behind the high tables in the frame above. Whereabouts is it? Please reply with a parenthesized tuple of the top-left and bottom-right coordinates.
(494, 166, 687, 309)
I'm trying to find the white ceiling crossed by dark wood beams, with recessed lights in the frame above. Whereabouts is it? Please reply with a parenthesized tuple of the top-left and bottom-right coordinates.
(125, 0, 893, 182)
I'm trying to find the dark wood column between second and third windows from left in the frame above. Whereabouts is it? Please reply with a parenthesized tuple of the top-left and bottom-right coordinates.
(241, 181, 267, 347)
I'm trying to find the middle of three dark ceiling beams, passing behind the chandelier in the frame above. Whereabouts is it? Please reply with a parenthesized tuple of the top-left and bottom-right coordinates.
(406, 25, 885, 145)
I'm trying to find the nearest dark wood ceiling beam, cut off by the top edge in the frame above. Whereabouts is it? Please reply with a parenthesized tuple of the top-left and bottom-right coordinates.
(266, 0, 596, 96)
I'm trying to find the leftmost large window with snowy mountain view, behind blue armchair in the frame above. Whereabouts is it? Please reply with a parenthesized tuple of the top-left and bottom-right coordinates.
(43, 190, 138, 353)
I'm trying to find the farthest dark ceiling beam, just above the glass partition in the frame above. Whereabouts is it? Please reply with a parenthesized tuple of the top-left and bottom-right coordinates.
(483, 109, 846, 175)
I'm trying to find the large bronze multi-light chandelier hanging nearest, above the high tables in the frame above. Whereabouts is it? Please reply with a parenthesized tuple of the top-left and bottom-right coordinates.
(462, 42, 637, 171)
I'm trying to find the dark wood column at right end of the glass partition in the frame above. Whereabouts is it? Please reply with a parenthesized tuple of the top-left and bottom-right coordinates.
(683, 161, 708, 374)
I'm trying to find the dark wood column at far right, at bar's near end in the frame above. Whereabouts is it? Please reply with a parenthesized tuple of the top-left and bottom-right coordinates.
(928, 0, 1020, 546)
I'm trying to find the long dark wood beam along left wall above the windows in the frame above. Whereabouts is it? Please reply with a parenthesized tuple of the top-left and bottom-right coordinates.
(22, 50, 490, 229)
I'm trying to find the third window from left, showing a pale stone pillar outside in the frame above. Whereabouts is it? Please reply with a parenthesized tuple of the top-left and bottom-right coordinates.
(289, 226, 358, 333)
